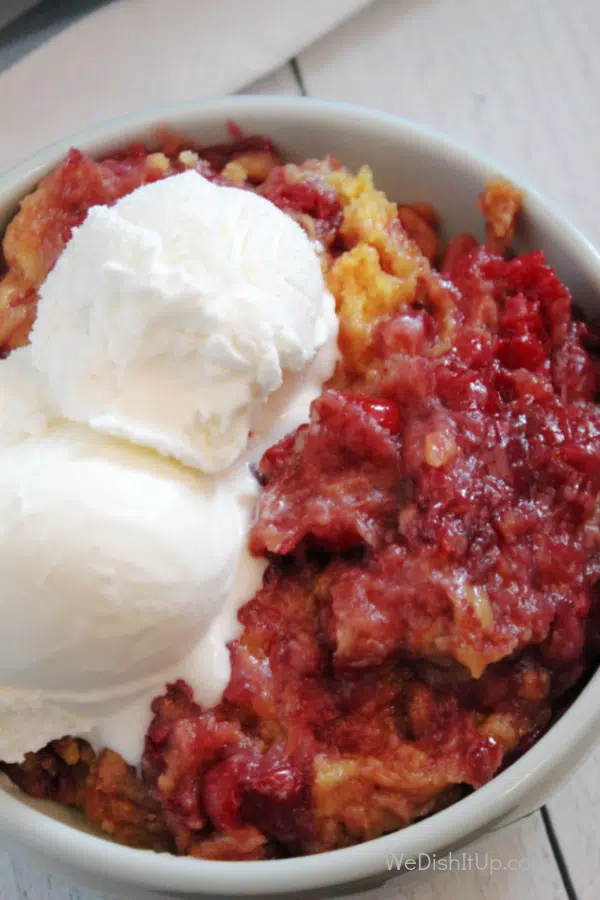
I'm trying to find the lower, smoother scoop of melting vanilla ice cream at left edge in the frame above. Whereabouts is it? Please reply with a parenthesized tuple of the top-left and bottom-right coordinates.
(0, 390, 264, 761)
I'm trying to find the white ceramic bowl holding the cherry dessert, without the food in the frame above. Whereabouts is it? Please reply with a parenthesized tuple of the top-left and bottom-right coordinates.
(0, 97, 600, 900)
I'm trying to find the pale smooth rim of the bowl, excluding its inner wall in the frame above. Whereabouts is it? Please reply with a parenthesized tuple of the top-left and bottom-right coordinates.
(0, 95, 600, 897)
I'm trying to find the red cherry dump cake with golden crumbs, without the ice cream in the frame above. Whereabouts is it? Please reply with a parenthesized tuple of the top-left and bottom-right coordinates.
(0, 134, 600, 860)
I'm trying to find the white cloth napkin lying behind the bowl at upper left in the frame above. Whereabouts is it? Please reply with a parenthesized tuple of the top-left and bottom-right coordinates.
(0, 0, 368, 173)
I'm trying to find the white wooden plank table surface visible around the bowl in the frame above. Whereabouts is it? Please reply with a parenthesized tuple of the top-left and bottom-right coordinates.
(0, 0, 600, 900)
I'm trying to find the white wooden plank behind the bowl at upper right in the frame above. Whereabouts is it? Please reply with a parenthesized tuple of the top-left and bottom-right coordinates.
(299, 0, 600, 244)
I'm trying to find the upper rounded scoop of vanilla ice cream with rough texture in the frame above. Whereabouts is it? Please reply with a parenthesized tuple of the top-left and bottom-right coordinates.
(31, 171, 331, 473)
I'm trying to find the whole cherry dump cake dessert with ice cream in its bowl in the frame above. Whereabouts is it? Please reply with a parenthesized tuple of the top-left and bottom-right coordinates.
(0, 99, 600, 895)
